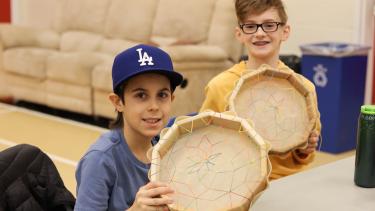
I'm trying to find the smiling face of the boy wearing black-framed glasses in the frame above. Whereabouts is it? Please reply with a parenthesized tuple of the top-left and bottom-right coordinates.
(236, 8, 290, 66)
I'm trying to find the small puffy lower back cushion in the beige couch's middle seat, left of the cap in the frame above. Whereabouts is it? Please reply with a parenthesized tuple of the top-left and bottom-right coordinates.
(60, 31, 103, 51)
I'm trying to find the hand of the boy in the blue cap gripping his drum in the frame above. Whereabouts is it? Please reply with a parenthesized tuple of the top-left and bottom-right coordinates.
(128, 182, 174, 211)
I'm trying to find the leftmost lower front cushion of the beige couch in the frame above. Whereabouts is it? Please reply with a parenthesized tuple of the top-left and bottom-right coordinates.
(3, 48, 56, 79)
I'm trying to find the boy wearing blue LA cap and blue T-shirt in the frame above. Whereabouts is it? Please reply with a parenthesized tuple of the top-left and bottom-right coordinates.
(74, 45, 182, 211)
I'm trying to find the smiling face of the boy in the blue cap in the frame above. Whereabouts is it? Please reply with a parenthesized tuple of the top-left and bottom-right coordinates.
(111, 73, 173, 141)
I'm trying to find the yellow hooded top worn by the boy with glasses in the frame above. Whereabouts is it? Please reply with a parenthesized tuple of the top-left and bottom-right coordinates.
(200, 61, 321, 180)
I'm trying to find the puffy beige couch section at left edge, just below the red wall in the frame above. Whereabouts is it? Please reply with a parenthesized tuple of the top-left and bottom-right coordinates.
(0, 24, 60, 49)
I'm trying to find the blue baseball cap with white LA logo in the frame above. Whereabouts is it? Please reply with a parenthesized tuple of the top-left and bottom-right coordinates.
(112, 44, 183, 90)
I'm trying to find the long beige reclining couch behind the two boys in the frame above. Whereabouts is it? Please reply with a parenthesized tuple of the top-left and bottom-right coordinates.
(0, 0, 241, 118)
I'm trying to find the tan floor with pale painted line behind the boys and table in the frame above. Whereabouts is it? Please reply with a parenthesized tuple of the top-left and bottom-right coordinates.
(0, 103, 355, 194)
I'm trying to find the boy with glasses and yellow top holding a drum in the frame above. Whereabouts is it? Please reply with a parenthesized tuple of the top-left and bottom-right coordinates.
(200, 0, 321, 180)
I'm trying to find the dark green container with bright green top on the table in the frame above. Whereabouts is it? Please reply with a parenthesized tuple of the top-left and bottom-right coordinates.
(354, 105, 375, 188)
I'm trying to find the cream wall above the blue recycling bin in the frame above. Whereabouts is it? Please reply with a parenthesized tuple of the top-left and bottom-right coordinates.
(282, 0, 359, 54)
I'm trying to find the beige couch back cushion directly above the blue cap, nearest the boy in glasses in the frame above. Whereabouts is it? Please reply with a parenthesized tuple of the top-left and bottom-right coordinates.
(152, 0, 216, 45)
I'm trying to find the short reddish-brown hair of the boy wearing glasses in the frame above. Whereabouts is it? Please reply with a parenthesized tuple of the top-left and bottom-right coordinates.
(235, 0, 288, 24)
